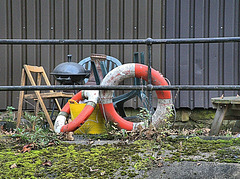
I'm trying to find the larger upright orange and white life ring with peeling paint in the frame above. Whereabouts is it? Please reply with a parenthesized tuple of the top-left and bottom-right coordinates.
(100, 63, 172, 131)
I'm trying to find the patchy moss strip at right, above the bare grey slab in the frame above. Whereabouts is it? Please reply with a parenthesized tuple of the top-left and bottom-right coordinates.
(159, 137, 240, 163)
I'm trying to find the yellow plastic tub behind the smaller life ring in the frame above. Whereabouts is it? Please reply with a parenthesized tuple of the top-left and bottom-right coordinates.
(68, 99, 106, 134)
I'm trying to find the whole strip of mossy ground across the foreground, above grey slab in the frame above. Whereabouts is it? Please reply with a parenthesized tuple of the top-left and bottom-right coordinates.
(0, 137, 240, 178)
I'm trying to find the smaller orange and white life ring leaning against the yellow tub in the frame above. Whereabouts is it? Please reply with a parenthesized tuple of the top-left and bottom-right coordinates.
(54, 90, 99, 133)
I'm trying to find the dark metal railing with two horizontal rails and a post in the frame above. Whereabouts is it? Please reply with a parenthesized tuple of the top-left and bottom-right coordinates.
(0, 37, 240, 111)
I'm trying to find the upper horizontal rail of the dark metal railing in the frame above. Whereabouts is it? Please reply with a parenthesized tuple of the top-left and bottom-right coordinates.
(0, 37, 240, 45)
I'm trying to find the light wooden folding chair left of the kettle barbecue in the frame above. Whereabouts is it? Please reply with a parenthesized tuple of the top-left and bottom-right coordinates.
(17, 65, 74, 129)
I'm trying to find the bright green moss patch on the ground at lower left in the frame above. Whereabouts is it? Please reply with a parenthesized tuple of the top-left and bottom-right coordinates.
(0, 141, 156, 178)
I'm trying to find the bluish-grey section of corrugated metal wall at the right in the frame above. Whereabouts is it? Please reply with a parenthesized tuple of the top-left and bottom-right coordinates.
(164, 0, 240, 108)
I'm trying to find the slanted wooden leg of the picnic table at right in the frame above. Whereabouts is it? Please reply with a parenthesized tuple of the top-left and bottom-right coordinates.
(209, 105, 228, 136)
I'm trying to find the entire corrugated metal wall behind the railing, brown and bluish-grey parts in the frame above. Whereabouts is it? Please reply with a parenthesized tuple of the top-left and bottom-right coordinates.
(0, 0, 240, 109)
